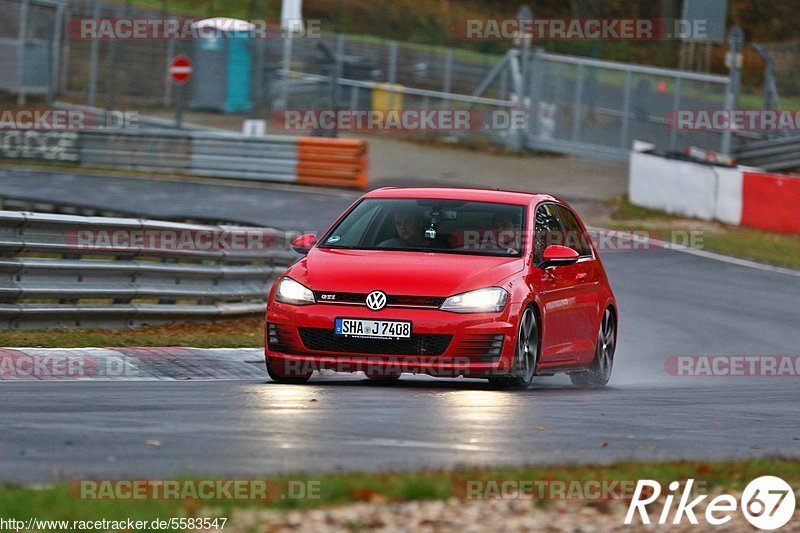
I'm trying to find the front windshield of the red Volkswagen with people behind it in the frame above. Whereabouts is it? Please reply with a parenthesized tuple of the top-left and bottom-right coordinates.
(320, 198, 525, 257)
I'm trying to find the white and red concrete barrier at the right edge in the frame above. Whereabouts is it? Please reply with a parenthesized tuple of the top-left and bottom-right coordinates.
(628, 143, 800, 233)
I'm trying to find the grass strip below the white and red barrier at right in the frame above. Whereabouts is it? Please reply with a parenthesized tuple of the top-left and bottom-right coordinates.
(600, 198, 800, 269)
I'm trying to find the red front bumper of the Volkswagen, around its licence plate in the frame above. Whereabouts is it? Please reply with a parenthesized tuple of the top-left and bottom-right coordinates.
(265, 302, 519, 377)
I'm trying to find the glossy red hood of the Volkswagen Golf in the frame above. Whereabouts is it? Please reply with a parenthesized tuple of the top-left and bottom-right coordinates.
(287, 248, 525, 297)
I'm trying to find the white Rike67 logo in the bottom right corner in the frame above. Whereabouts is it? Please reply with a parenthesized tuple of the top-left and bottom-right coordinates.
(625, 476, 795, 530)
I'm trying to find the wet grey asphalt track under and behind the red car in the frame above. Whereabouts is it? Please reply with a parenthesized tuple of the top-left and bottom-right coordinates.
(0, 171, 800, 481)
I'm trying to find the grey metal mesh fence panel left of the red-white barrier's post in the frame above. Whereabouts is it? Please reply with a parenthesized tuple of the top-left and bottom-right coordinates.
(526, 51, 729, 161)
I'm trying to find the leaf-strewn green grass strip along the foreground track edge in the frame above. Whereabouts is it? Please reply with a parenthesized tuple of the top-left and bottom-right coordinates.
(0, 459, 800, 520)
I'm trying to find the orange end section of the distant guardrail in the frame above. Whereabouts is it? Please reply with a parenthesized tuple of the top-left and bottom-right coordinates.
(297, 137, 369, 189)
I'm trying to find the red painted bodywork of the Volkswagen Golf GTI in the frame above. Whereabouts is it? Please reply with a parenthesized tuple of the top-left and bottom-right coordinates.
(266, 188, 617, 377)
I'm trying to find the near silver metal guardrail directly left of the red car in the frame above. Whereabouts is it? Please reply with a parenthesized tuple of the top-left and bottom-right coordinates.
(0, 211, 295, 329)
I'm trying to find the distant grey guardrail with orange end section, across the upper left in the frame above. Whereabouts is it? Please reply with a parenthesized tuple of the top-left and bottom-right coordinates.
(0, 128, 368, 189)
